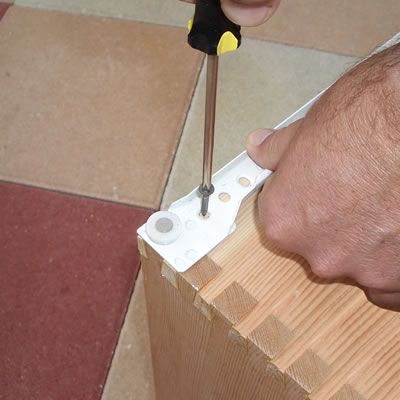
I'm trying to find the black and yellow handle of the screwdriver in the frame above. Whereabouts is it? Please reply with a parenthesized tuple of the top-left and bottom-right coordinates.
(188, 0, 242, 56)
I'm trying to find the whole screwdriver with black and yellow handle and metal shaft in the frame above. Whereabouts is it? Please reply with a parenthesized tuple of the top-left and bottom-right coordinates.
(188, 0, 241, 217)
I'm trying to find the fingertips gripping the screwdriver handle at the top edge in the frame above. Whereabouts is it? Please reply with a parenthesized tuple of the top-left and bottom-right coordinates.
(182, 0, 281, 26)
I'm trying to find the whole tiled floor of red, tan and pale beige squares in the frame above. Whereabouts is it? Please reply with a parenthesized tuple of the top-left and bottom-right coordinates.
(0, 0, 400, 400)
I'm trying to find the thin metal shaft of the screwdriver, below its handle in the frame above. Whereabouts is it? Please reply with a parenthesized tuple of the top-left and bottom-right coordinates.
(200, 55, 218, 216)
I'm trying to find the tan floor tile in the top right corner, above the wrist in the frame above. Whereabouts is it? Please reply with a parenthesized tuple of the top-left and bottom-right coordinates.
(245, 0, 400, 56)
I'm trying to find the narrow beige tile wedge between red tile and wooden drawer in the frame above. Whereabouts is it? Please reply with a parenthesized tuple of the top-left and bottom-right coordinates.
(102, 273, 155, 400)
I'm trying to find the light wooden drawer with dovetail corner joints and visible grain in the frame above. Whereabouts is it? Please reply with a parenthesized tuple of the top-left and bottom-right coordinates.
(141, 195, 400, 400)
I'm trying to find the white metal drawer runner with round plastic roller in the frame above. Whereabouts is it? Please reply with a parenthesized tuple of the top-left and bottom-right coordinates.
(138, 92, 323, 272)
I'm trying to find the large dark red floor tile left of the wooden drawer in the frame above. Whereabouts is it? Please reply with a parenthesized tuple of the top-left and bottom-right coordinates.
(0, 183, 150, 400)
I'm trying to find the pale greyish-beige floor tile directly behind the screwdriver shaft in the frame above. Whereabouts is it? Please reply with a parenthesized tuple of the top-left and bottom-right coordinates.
(162, 39, 356, 208)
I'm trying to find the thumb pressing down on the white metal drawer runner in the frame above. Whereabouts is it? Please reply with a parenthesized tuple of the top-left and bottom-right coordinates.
(246, 120, 301, 171)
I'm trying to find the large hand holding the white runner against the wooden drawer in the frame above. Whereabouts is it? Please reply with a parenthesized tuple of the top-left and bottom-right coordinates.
(247, 45, 400, 311)
